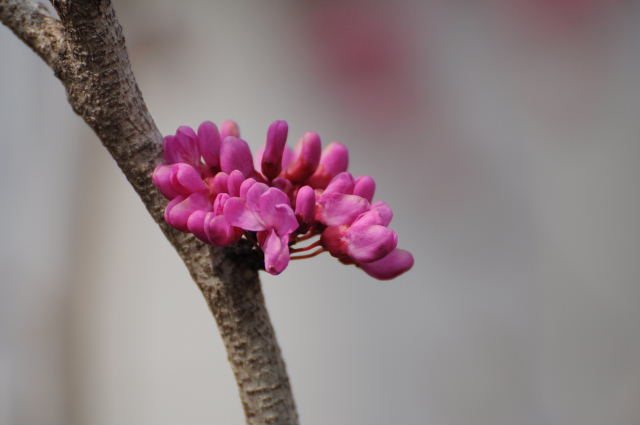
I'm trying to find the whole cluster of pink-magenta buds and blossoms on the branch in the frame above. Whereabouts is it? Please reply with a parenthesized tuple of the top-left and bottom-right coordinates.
(153, 121, 413, 279)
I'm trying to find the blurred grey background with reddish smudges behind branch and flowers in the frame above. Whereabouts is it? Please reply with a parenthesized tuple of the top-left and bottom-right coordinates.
(0, 0, 640, 424)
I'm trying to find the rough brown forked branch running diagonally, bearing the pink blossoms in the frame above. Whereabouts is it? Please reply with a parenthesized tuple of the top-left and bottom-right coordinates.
(0, 0, 298, 424)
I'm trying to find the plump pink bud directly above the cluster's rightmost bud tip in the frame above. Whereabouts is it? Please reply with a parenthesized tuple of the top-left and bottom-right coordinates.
(345, 225, 398, 263)
